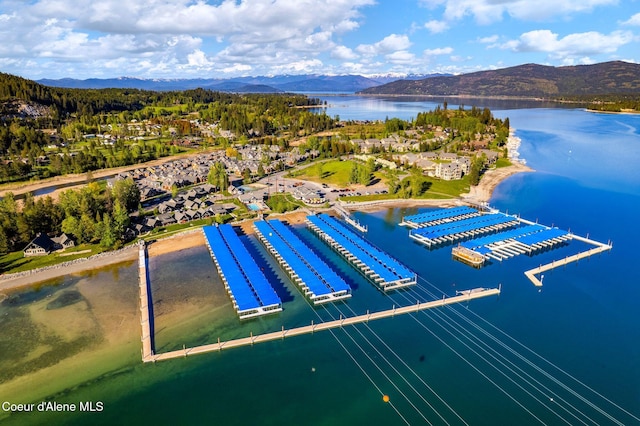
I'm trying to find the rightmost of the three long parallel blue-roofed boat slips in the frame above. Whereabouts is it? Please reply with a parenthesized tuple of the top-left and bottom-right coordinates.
(307, 214, 417, 291)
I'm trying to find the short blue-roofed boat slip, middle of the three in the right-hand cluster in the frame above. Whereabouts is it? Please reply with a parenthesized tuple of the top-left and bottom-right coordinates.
(409, 213, 520, 247)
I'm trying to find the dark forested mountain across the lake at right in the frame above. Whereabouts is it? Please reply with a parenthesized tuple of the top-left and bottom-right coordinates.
(358, 61, 640, 99)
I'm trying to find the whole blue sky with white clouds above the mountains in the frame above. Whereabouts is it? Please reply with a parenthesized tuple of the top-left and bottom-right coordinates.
(0, 0, 640, 79)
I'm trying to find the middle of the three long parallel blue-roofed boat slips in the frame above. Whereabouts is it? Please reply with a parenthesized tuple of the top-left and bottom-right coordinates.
(253, 219, 351, 305)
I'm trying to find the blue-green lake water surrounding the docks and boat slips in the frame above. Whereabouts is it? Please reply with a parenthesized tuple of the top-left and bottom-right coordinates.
(0, 96, 640, 425)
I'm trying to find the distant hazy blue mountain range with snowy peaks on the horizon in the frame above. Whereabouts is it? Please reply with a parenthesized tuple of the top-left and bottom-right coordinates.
(37, 74, 443, 93)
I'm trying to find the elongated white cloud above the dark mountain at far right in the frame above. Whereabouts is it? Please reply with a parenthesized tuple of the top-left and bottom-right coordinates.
(503, 30, 633, 59)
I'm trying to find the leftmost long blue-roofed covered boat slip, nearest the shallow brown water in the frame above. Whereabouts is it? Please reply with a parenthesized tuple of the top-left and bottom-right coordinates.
(202, 225, 282, 319)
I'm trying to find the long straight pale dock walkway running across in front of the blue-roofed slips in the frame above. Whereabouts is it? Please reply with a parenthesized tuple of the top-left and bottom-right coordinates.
(142, 288, 500, 362)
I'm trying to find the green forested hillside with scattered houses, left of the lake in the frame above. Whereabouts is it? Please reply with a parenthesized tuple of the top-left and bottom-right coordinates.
(0, 74, 334, 183)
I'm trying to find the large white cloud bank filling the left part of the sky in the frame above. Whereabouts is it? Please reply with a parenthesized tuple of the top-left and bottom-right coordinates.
(0, 0, 376, 76)
